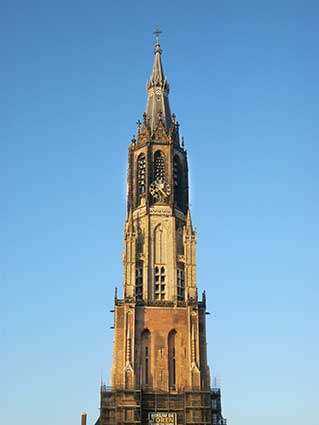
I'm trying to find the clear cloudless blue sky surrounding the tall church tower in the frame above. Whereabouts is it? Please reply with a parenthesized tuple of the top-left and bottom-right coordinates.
(0, 0, 319, 425)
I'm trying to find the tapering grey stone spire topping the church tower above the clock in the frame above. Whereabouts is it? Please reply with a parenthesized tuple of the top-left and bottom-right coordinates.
(146, 31, 171, 131)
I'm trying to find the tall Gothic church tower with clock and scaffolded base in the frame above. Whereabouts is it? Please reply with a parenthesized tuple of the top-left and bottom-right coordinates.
(100, 33, 226, 425)
